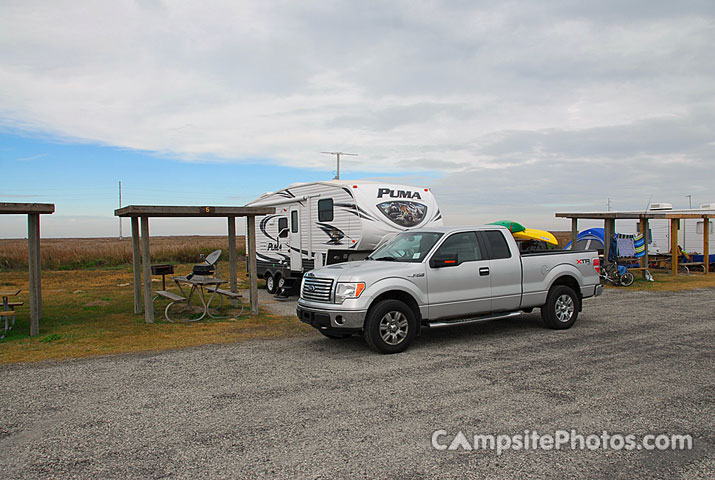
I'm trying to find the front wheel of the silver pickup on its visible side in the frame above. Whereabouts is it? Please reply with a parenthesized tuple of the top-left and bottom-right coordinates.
(364, 300, 417, 353)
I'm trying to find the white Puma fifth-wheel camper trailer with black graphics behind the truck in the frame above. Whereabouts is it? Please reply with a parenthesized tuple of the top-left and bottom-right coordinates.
(248, 180, 442, 293)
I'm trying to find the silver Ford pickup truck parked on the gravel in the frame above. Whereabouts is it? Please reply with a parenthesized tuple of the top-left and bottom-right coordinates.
(297, 225, 603, 353)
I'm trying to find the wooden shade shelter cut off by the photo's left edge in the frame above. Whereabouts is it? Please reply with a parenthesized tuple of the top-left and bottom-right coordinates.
(0, 203, 55, 336)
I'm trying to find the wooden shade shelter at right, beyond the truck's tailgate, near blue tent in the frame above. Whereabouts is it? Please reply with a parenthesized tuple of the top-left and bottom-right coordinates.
(556, 209, 715, 275)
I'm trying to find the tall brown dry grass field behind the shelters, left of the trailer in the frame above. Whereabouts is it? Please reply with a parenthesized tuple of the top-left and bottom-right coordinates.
(0, 236, 246, 270)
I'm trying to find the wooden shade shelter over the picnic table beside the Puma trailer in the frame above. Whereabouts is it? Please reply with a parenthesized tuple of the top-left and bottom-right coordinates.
(114, 205, 275, 323)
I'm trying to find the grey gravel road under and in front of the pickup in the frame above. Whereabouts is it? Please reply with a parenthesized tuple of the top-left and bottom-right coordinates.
(0, 289, 715, 479)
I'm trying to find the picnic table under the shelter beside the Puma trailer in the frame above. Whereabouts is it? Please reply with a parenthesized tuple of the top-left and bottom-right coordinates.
(156, 275, 243, 322)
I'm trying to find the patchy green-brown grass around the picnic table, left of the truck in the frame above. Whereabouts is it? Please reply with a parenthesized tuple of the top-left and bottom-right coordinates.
(0, 264, 311, 363)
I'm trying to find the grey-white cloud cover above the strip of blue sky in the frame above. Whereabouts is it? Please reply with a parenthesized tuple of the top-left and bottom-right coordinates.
(0, 0, 715, 232)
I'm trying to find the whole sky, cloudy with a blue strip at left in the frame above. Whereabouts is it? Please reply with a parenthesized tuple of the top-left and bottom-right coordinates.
(0, 0, 715, 238)
